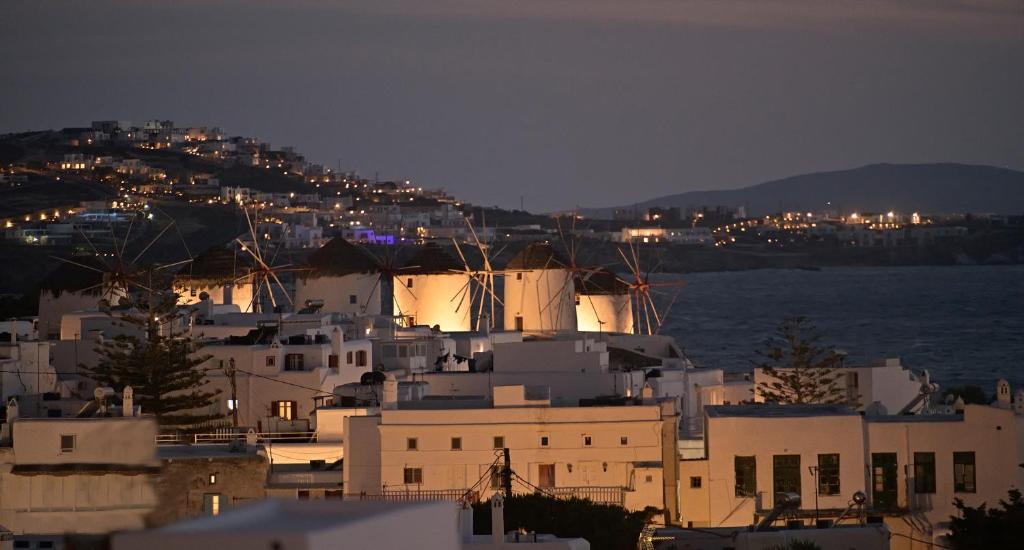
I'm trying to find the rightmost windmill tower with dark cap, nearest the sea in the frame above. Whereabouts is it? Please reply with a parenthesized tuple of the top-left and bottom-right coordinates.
(575, 269, 633, 333)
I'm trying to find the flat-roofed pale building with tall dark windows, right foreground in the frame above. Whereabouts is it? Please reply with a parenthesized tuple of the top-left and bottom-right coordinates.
(679, 390, 1024, 548)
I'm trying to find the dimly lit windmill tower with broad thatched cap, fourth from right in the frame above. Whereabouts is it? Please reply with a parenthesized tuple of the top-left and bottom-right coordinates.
(295, 237, 381, 315)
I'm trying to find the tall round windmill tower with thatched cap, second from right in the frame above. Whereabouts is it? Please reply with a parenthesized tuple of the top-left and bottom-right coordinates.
(504, 242, 577, 332)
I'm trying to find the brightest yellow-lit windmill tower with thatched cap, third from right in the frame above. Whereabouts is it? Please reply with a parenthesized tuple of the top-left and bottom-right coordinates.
(393, 243, 472, 332)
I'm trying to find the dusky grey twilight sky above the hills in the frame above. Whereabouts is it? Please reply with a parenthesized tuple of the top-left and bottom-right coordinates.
(0, 0, 1024, 211)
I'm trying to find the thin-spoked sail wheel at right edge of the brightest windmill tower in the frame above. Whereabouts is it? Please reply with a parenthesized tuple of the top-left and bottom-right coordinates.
(449, 218, 505, 331)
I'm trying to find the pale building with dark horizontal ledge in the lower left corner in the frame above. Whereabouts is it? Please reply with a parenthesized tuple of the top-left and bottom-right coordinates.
(0, 397, 160, 548)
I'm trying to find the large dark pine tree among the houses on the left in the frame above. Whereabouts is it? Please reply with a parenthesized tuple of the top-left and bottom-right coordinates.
(82, 293, 223, 429)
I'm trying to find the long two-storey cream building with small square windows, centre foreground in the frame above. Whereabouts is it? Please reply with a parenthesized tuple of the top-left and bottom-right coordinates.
(344, 386, 678, 517)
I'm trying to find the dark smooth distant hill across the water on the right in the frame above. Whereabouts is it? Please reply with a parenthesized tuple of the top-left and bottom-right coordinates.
(584, 164, 1024, 218)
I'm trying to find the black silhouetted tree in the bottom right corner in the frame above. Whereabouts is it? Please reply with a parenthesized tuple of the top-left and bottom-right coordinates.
(949, 489, 1024, 550)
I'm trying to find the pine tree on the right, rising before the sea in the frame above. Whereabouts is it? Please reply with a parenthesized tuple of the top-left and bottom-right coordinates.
(755, 316, 854, 405)
